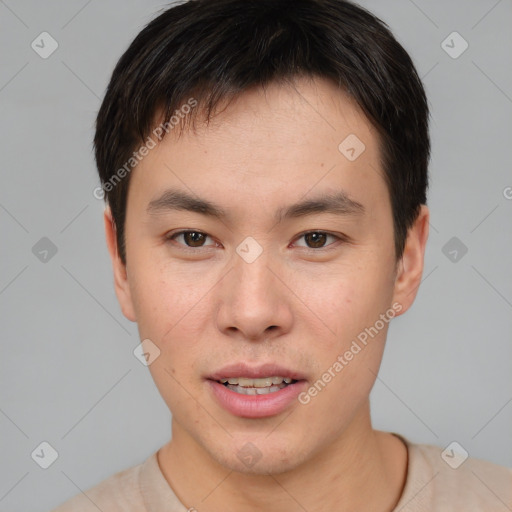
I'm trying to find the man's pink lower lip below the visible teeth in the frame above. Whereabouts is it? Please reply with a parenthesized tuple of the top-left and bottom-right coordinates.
(208, 380, 307, 418)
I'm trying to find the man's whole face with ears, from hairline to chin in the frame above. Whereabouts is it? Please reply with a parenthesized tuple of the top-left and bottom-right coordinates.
(106, 80, 428, 473)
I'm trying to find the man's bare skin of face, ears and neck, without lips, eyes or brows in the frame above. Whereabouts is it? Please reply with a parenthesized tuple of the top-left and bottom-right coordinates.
(105, 79, 429, 512)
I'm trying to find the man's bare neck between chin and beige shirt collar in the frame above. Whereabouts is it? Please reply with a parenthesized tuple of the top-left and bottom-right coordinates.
(158, 402, 407, 512)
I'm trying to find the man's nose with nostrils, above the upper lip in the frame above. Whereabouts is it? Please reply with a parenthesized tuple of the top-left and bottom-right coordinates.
(217, 247, 293, 341)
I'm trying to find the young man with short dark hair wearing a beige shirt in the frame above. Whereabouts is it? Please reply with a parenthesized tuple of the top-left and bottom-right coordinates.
(52, 0, 512, 512)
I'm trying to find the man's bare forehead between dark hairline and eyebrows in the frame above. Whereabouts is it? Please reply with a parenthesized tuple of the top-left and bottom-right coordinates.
(129, 79, 386, 217)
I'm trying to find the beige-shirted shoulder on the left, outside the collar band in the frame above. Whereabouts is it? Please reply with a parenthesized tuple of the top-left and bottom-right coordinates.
(52, 454, 145, 512)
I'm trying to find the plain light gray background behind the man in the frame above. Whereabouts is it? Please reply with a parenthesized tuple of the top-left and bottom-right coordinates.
(0, 0, 512, 512)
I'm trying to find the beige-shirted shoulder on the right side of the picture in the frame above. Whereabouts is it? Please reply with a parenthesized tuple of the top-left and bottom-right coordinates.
(396, 436, 512, 512)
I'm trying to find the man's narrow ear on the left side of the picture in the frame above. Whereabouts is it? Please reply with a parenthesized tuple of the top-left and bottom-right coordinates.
(103, 206, 136, 322)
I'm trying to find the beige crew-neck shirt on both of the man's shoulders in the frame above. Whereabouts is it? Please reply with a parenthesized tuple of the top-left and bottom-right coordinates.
(53, 434, 512, 512)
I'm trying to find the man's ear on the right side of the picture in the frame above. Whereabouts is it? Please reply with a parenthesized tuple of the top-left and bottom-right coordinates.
(393, 205, 430, 316)
